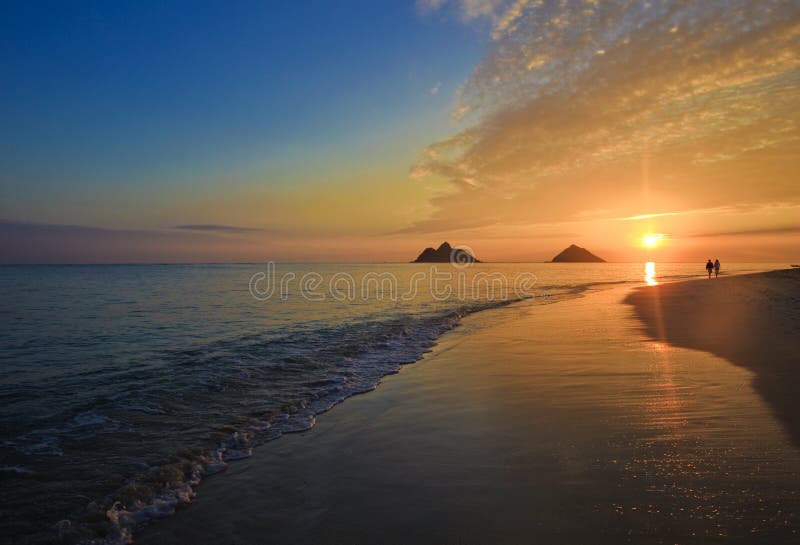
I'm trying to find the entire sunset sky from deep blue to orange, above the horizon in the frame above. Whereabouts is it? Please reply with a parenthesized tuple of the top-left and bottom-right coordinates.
(0, 0, 800, 263)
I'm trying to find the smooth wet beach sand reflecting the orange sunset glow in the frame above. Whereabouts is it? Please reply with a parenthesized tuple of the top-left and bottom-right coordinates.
(136, 273, 800, 545)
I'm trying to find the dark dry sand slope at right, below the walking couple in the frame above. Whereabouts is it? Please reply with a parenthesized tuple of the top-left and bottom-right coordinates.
(625, 269, 800, 446)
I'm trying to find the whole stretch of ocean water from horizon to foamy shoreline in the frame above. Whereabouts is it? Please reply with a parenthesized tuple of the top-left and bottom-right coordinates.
(0, 263, 785, 543)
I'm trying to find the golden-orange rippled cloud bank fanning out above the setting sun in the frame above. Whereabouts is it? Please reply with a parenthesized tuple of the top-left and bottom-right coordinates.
(407, 0, 800, 233)
